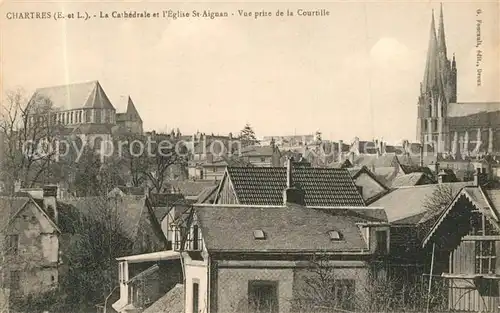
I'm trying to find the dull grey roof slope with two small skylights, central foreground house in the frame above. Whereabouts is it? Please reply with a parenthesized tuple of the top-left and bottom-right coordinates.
(194, 205, 376, 252)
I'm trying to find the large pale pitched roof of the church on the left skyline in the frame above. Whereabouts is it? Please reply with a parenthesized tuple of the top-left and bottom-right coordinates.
(32, 80, 115, 110)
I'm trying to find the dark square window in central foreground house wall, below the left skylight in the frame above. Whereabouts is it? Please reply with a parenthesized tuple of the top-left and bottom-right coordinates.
(248, 280, 279, 313)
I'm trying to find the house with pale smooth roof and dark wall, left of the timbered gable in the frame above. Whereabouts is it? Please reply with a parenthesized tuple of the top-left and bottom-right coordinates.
(370, 182, 473, 305)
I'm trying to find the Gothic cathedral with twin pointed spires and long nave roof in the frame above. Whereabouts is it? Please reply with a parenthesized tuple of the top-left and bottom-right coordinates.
(417, 6, 500, 159)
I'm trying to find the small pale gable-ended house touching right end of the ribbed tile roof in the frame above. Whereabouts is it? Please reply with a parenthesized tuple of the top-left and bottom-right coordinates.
(347, 166, 389, 203)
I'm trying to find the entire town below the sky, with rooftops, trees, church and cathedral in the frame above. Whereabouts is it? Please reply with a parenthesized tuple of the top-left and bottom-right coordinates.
(0, 5, 500, 313)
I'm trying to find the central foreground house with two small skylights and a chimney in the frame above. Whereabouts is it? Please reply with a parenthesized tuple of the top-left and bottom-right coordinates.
(175, 193, 389, 313)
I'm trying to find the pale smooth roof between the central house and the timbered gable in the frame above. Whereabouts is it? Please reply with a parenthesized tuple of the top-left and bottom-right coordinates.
(370, 182, 471, 223)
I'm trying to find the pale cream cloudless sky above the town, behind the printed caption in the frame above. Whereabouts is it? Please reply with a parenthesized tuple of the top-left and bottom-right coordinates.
(0, 1, 500, 142)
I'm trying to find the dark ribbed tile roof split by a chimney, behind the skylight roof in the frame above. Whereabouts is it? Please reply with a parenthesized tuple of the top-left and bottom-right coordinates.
(227, 167, 365, 206)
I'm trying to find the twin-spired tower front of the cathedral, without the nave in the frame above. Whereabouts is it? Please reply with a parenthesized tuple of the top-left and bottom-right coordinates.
(417, 6, 457, 152)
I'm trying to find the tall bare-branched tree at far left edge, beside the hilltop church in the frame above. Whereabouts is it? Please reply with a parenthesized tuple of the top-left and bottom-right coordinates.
(0, 89, 65, 190)
